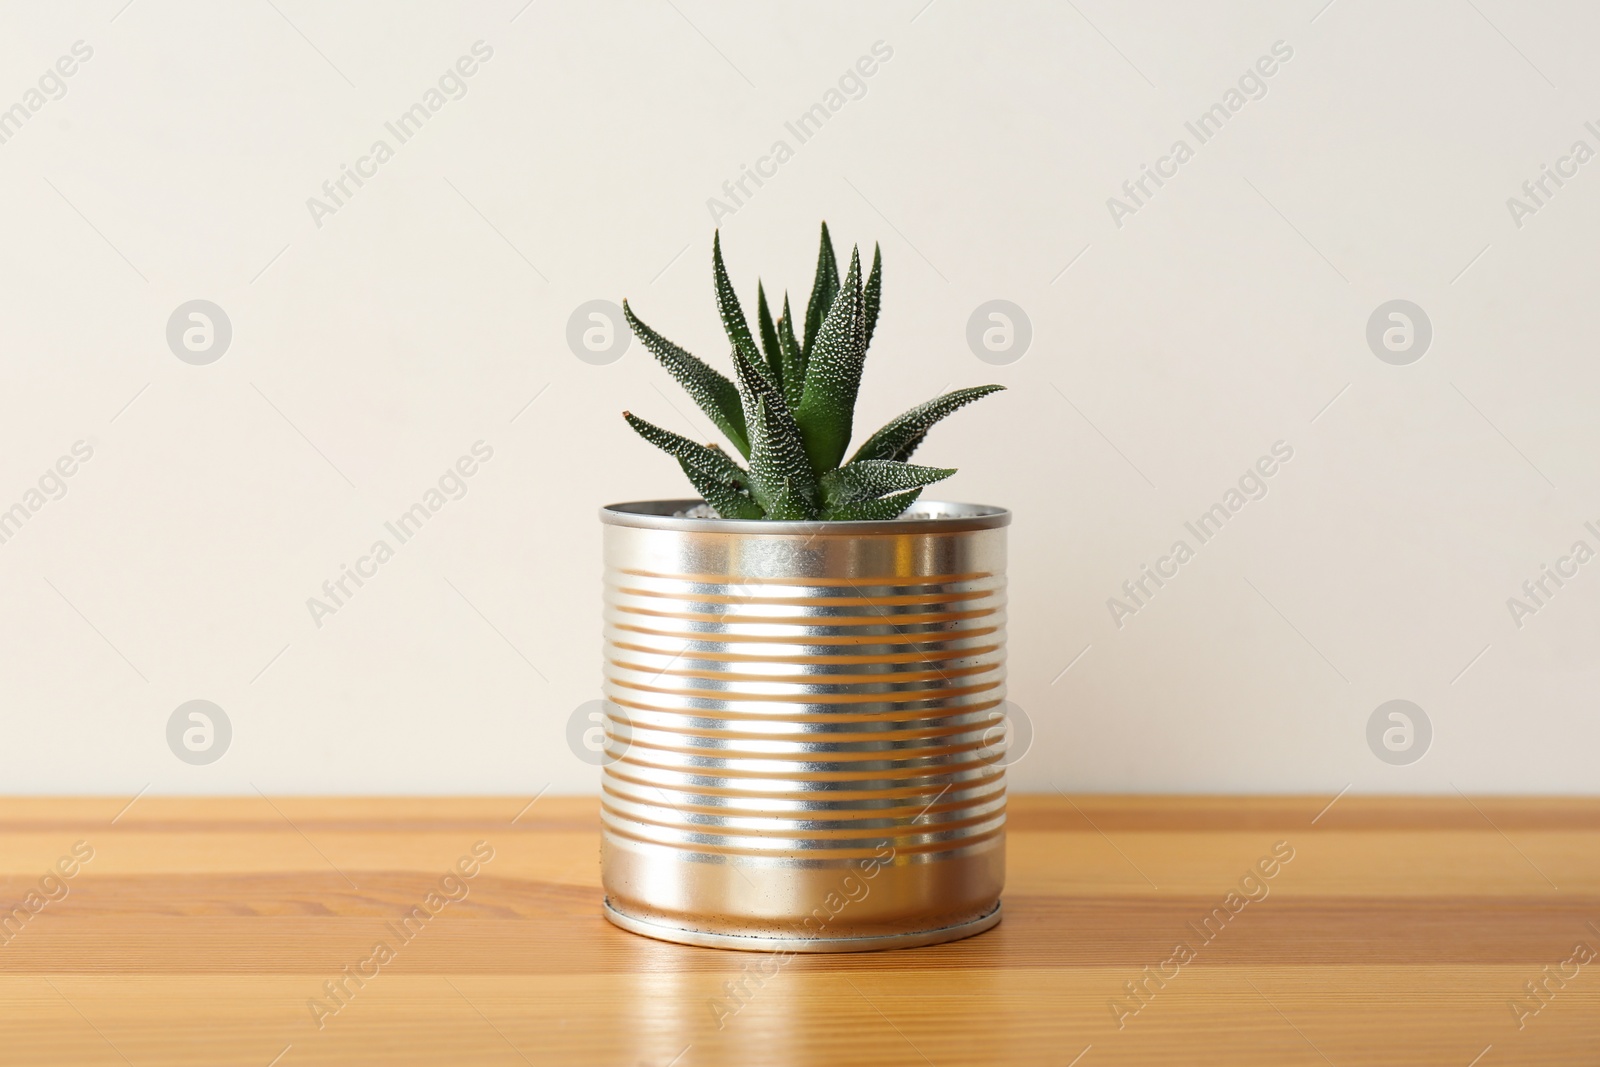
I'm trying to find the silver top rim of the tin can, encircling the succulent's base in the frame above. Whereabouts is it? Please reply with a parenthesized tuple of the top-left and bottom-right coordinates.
(600, 498, 1011, 537)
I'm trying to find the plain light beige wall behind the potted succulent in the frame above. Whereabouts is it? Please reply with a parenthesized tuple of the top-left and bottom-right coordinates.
(0, 0, 1600, 797)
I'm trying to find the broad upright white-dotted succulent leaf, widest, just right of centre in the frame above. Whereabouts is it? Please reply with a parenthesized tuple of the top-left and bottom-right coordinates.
(795, 250, 870, 474)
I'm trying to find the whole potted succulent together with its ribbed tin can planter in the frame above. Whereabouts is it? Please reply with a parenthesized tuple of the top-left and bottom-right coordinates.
(600, 224, 1010, 952)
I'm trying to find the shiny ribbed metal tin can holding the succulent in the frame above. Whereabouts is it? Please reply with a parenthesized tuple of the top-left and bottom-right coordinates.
(600, 501, 1011, 952)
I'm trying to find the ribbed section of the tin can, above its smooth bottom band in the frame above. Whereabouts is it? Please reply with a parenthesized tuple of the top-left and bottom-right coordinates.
(603, 504, 1008, 947)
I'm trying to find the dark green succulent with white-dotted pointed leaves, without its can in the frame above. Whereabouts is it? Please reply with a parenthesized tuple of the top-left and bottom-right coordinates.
(622, 222, 1005, 520)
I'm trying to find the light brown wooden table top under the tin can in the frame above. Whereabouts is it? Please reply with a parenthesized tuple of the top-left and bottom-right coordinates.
(0, 795, 1600, 1067)
